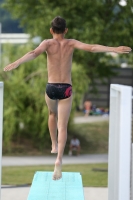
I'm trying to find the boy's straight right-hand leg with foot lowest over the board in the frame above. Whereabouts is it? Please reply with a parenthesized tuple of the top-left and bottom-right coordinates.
(53, 96, 72, 180)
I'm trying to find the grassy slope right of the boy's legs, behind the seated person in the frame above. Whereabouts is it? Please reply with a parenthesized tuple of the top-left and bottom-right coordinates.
(65, 121, 109, 154)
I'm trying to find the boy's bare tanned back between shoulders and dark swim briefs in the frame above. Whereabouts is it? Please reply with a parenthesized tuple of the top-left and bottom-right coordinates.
(46, 38, 74, 84)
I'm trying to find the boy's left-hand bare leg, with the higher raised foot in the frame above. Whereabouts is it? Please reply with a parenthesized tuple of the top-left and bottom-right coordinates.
(45, 94, 58, 153)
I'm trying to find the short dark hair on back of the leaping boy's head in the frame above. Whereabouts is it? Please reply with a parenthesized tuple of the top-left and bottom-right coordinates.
(51, 16, 66, 34)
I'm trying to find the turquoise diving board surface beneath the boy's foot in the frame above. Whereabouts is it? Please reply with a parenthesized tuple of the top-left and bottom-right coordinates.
(27, 171, 84, 200)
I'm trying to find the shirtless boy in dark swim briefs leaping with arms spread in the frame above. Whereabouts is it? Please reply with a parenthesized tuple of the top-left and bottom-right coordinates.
(4, 16, 131, 180)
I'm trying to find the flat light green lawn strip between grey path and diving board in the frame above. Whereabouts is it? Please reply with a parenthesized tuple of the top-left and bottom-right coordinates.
(2, 164, 108, 187)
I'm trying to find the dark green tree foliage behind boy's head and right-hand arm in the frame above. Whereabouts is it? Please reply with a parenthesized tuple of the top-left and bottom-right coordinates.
(2, 0, 133, 76)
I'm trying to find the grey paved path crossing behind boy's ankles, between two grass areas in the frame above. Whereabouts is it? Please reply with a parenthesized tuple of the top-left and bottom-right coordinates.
(2, 154, 108, 166)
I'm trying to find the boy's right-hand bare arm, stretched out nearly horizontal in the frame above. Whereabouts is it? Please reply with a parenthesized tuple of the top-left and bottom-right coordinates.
(73, 40, 132, 53)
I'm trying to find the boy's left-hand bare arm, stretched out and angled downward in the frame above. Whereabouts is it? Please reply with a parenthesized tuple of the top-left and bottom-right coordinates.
(4, 40, 47, 71)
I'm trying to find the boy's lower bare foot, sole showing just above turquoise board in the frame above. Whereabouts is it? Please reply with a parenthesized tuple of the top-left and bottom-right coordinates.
(53, 160, 62, 180)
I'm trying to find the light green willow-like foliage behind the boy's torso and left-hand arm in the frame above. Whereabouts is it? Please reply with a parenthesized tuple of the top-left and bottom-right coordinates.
(0, 44, 89, 151)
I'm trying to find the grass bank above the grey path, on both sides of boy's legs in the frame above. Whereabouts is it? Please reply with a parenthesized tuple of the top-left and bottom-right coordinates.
(3, 121, 109, 156)
